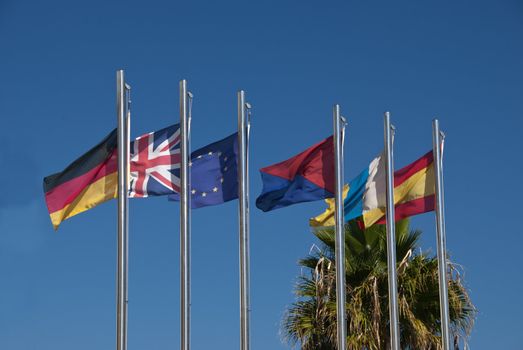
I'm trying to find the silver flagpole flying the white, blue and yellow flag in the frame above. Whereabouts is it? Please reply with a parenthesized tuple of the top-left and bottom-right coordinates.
(384, 112, 400, 350)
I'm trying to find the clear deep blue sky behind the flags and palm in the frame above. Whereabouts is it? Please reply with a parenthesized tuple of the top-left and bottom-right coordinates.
(0, 0, 523, 350)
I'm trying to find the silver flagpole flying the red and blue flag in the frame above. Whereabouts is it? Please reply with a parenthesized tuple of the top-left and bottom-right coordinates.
(333, 105, 347, 349)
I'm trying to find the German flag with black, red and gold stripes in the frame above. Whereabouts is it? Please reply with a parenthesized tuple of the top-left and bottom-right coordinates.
(44, 129, 118, 230)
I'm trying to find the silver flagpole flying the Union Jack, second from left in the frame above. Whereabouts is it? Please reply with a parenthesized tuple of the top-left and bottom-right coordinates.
(180, 80, 191, 350)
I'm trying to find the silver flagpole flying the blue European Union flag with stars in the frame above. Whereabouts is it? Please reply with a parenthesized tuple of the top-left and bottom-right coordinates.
(238, 90, 251, 350)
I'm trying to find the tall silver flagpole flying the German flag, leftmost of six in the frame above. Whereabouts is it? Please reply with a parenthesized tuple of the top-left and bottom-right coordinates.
(116, 70, 129, 350)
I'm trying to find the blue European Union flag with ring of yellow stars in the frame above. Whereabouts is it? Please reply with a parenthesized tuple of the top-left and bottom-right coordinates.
(169, 133, 238, 209)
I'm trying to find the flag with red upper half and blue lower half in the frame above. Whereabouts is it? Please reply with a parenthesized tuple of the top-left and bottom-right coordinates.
(256, 136, 335, 211)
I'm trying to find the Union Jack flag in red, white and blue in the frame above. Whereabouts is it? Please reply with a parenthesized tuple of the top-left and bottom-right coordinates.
(129, 124, 181, 198)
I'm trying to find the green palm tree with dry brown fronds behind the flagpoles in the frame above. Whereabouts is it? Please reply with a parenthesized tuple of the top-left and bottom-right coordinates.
(282, 220, 476, 350)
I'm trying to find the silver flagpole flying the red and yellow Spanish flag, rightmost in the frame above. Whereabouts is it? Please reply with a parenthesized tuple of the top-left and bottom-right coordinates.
(432, 119, 450, 350)
